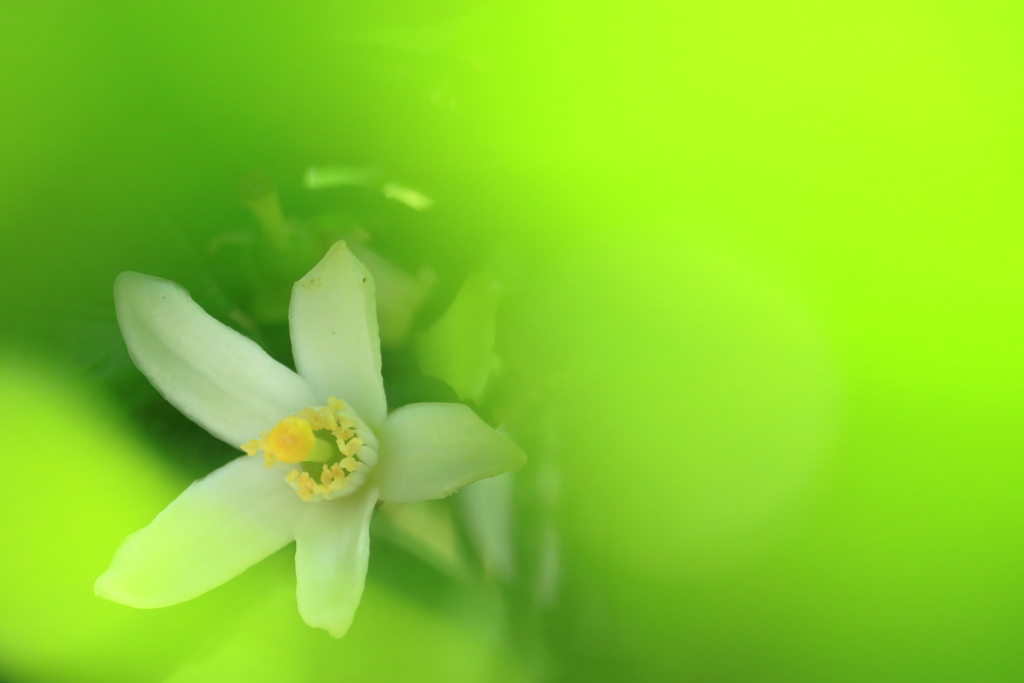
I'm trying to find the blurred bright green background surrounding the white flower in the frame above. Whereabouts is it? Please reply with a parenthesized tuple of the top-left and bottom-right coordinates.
(0, 0, 1024, 682)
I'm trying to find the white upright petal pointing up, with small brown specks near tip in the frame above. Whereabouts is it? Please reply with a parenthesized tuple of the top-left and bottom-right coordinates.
(288, 242, 387, 429)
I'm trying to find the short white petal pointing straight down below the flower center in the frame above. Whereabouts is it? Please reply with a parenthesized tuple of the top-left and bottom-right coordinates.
(295, 486, 377, 638)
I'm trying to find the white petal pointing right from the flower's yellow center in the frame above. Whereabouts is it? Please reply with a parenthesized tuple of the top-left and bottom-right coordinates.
(375, 403, 526, 503)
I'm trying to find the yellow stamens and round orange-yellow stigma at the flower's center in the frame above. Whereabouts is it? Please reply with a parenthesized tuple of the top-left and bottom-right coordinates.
(242, 396, 377, 502)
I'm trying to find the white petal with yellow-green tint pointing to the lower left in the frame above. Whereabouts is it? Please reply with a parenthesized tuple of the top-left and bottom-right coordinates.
(95, 456, 307, 608)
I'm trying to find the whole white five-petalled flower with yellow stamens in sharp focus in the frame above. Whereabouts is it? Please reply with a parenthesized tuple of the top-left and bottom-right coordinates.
(95, 242, 525, 638)
